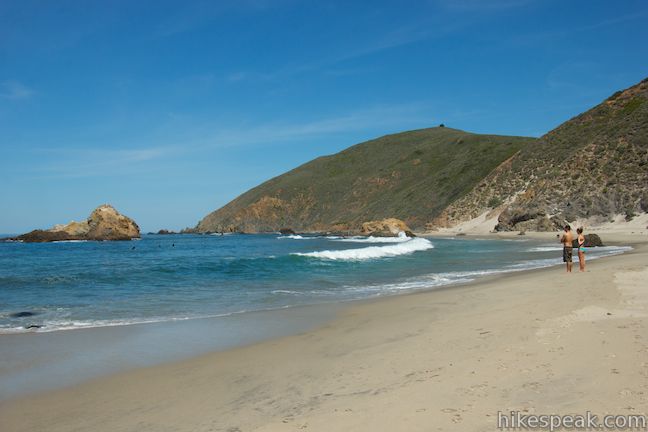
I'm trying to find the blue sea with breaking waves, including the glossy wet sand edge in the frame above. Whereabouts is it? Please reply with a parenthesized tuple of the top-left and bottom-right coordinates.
(0, 234, 627, 400)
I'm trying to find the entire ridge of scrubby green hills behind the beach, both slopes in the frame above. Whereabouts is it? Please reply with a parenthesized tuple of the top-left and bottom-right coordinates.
(197, 79, 648, 232)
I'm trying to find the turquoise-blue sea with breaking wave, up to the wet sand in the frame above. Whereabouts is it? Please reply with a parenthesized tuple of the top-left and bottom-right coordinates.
(0, 235, 623, 333)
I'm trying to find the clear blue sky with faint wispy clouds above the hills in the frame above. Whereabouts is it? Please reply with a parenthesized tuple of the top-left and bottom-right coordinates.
(0, 0, 648, 233)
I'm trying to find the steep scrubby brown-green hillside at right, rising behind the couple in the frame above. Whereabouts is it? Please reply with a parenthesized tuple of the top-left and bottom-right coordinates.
(430, 79, 648, 230)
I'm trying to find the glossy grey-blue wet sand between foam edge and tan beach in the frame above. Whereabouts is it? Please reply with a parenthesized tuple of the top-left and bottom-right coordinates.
(0, 303, 343, 403)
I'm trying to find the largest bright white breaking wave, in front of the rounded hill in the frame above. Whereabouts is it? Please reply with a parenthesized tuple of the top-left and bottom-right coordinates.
(293, 238, 434, 261)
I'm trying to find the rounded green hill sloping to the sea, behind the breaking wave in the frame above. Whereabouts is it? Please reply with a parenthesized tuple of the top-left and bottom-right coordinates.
(197, 127, 535, 232)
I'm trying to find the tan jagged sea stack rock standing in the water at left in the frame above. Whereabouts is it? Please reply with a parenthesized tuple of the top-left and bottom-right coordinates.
(13, 204, 140, 242)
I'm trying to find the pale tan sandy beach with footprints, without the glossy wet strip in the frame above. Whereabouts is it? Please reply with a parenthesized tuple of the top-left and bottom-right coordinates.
(0, 234, 648, 432)
